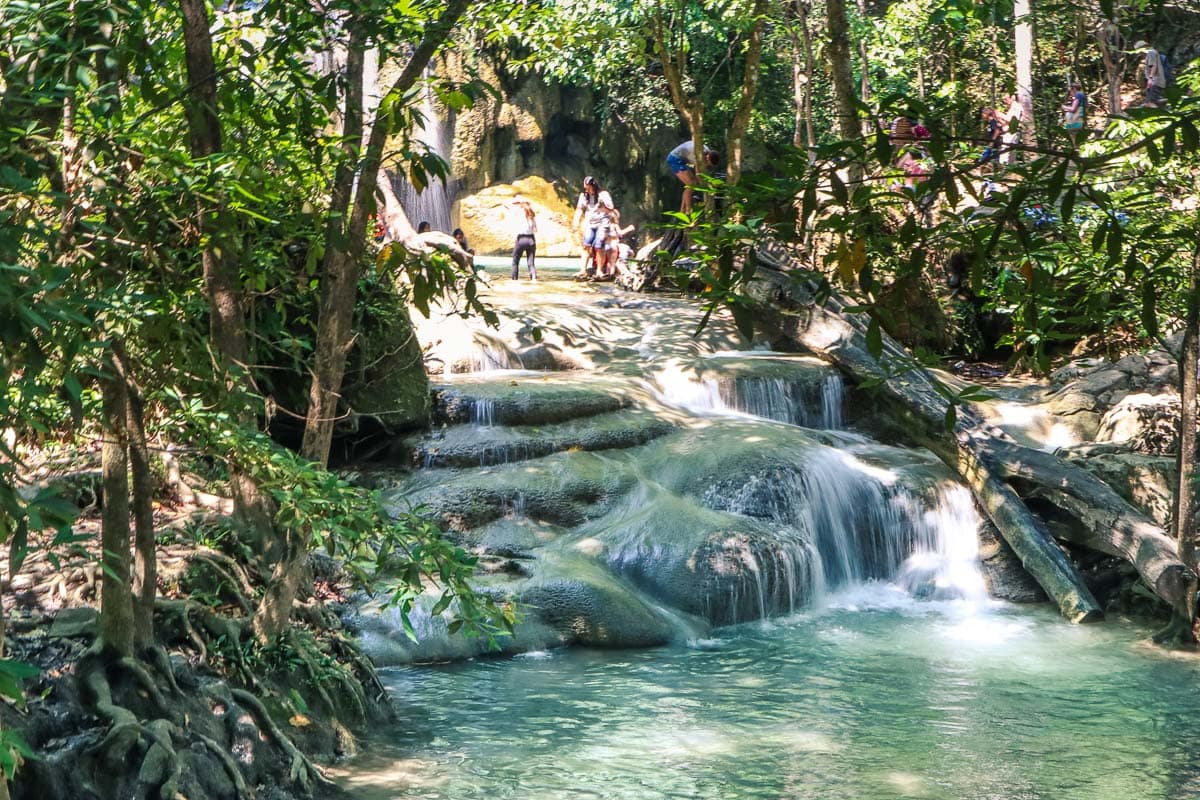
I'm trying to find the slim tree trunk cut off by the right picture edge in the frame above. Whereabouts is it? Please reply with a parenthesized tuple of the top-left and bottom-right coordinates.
(1171, 235, 1200, 639)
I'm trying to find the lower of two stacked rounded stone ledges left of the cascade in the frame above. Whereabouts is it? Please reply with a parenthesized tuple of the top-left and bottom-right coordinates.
(409, 409, 674, 467)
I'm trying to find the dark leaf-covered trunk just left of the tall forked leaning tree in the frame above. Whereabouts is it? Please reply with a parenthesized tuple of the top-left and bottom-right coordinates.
(179, 0, 271, 542)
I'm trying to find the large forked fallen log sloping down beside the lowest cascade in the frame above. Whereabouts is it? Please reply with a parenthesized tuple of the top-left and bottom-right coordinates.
(746, 248, 1195, 622)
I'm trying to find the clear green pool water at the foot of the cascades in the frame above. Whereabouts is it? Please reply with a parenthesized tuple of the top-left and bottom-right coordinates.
(341, 599, 1200, 800)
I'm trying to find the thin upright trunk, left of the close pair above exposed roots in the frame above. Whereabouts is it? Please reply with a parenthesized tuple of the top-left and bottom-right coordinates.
(100, 361, 133, 658)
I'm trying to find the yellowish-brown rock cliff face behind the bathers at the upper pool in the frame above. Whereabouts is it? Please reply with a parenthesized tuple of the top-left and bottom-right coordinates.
(424, 54, 683, 255)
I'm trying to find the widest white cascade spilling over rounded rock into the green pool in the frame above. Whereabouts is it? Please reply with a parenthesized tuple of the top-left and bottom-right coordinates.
(704, 447, 986, 621)
